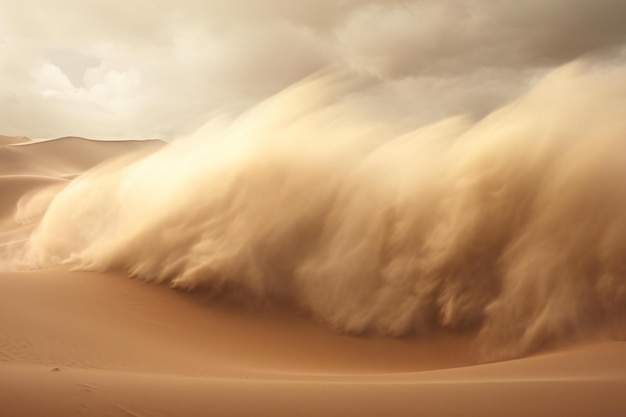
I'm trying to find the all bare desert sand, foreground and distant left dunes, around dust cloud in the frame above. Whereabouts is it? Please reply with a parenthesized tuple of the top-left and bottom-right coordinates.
(0, 137, 626, 417)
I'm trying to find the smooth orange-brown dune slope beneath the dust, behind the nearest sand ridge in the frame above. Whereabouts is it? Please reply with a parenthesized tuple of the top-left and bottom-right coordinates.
(0, 268, 478, 376)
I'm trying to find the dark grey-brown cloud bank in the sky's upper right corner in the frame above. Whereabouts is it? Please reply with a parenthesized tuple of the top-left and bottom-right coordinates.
(337, 0, 626, 77)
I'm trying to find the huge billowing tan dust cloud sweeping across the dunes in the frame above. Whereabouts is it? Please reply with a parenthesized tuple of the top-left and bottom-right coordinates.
(14, 62, 626, 357)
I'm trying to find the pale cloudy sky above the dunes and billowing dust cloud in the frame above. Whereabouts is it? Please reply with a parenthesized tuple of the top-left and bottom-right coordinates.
(0, 0, 626, 140)
